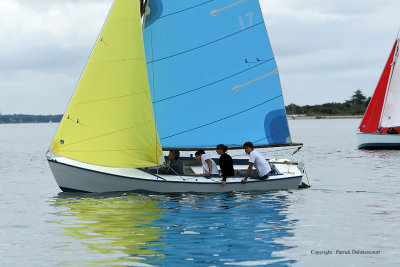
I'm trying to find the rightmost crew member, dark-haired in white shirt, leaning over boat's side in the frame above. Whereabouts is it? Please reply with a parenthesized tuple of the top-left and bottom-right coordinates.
(241, 142, 271, 184)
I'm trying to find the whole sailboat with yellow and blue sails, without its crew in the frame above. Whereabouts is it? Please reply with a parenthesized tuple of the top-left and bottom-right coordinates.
(46, 0, 303, 193)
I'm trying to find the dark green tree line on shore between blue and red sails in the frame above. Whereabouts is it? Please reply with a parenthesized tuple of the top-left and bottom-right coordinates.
(286, 90, 371, 116)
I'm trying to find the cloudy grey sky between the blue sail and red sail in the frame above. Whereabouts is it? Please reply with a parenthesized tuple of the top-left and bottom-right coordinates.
(260, 0, 400, 105)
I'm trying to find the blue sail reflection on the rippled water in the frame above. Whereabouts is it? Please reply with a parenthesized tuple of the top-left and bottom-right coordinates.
(147, 192, 296, 266)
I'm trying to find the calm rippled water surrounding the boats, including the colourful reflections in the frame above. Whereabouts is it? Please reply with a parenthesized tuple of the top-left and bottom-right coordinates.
(0, 119, 400, 266)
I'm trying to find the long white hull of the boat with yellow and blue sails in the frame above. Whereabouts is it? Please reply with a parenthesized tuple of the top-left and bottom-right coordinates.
(48, 158, 302, 193)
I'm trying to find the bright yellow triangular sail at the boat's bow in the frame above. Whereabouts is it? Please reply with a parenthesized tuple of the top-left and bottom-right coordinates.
(52, 0, 162, 167)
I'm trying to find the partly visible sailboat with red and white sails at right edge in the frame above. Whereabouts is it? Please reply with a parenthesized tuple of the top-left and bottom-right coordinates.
(357, 36, 400, 149)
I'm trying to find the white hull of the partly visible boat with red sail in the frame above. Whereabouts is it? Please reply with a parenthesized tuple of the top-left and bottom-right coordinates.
(357, 132, 400, 149)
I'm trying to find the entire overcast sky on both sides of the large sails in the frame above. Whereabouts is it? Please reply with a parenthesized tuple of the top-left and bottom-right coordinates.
(0, 0, 400, 114)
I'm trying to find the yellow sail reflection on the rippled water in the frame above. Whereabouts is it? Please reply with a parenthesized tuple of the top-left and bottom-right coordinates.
(54, 193, 162, 266)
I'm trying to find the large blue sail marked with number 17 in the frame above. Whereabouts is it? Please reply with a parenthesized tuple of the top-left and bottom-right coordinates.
(144, 0, 291, 148)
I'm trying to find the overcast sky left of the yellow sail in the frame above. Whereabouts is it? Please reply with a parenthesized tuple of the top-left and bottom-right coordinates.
(0, 0, 112, 114)
